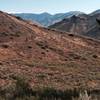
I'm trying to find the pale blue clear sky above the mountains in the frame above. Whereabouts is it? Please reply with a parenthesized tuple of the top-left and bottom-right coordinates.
(0, 0, 100, 14)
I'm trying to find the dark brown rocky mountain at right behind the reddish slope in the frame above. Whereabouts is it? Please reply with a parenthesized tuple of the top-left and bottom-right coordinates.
(49, 10, 100, 40)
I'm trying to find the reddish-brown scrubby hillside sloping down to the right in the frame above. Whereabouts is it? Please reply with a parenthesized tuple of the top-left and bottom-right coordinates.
(0, 12, 100, 97)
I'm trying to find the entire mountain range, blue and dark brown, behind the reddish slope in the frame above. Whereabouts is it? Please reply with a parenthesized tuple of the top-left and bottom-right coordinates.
(14, 10, 100, 39)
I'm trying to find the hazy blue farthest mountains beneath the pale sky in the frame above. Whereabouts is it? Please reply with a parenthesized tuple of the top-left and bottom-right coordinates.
(14, 11, 83, 27)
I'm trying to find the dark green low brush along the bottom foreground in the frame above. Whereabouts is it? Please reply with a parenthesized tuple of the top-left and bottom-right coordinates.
(0, 77, 100, 100)
